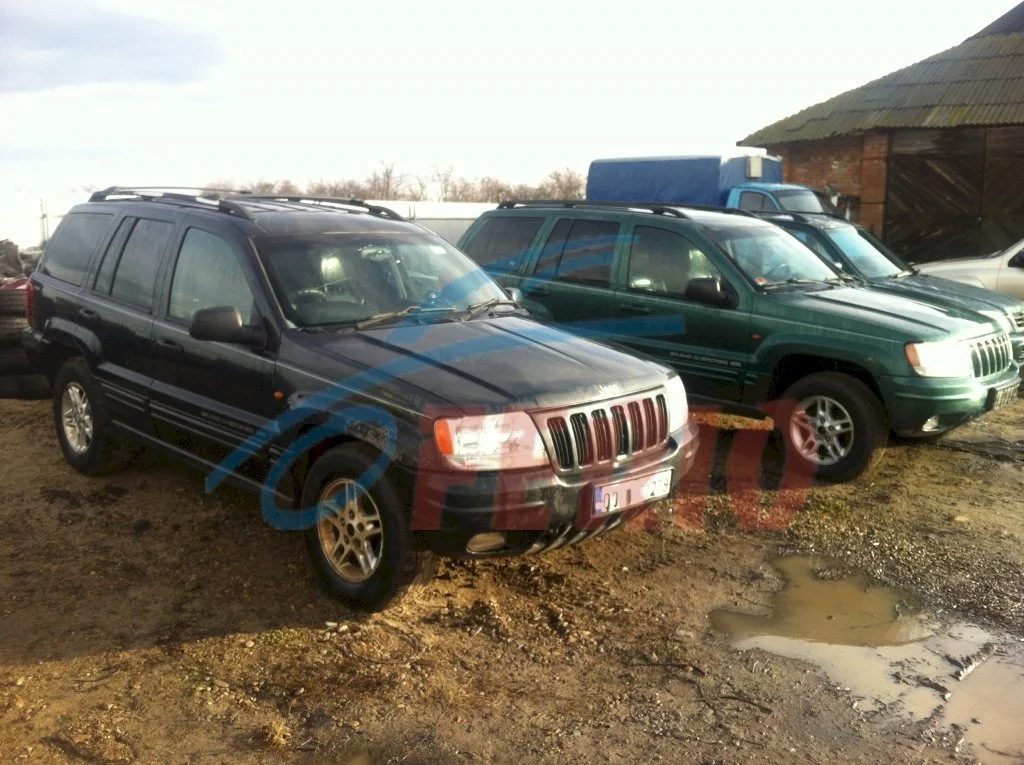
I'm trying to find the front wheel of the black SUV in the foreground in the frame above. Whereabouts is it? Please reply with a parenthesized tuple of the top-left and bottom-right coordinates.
(302, 443, 433, 611)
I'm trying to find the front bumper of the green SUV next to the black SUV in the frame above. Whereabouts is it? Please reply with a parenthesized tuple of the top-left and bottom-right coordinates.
(879, 364, 1021, 436)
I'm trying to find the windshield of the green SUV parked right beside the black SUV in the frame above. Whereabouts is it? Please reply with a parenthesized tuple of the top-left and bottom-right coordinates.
(708, 225, 839, 285)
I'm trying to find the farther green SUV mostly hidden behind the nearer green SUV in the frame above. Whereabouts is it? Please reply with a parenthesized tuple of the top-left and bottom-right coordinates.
(762, 213, 1024, 364)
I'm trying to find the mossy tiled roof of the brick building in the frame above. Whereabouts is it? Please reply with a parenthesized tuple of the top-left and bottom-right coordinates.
(738, 3, 1024, 146)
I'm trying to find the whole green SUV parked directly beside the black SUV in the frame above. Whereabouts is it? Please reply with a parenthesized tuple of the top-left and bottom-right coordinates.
(458, 200, 1020, 480)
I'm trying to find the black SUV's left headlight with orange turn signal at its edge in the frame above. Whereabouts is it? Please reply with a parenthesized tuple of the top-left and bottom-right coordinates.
(434, 412, 548, 470)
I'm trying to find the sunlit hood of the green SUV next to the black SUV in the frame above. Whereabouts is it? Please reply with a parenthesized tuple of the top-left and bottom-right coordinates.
(769, 287, 995, 340)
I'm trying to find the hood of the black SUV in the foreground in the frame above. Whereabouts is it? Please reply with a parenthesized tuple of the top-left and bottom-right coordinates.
(299, 316, 670, 409)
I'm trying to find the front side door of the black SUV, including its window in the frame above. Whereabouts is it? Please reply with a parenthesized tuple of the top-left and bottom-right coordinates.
(153, 216, 284, 470)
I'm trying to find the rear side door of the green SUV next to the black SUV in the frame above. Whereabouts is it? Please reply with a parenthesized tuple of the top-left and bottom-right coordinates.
(521, 216, 623, 329)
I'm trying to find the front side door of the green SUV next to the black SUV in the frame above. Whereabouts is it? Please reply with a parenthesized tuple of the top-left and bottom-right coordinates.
(614, 221, 751, 401)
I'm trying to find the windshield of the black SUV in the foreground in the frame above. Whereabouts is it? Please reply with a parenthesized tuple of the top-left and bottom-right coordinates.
(256, 231, 508, 327)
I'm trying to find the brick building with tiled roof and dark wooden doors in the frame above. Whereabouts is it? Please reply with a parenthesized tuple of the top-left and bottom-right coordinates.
(738, 3, 1024, 262)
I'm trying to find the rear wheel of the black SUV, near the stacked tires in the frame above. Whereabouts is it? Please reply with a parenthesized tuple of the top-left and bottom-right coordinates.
(52, 357, 119, 475)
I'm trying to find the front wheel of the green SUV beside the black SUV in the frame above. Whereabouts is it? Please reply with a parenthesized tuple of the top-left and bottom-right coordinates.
(776, 372, 888, 482)
